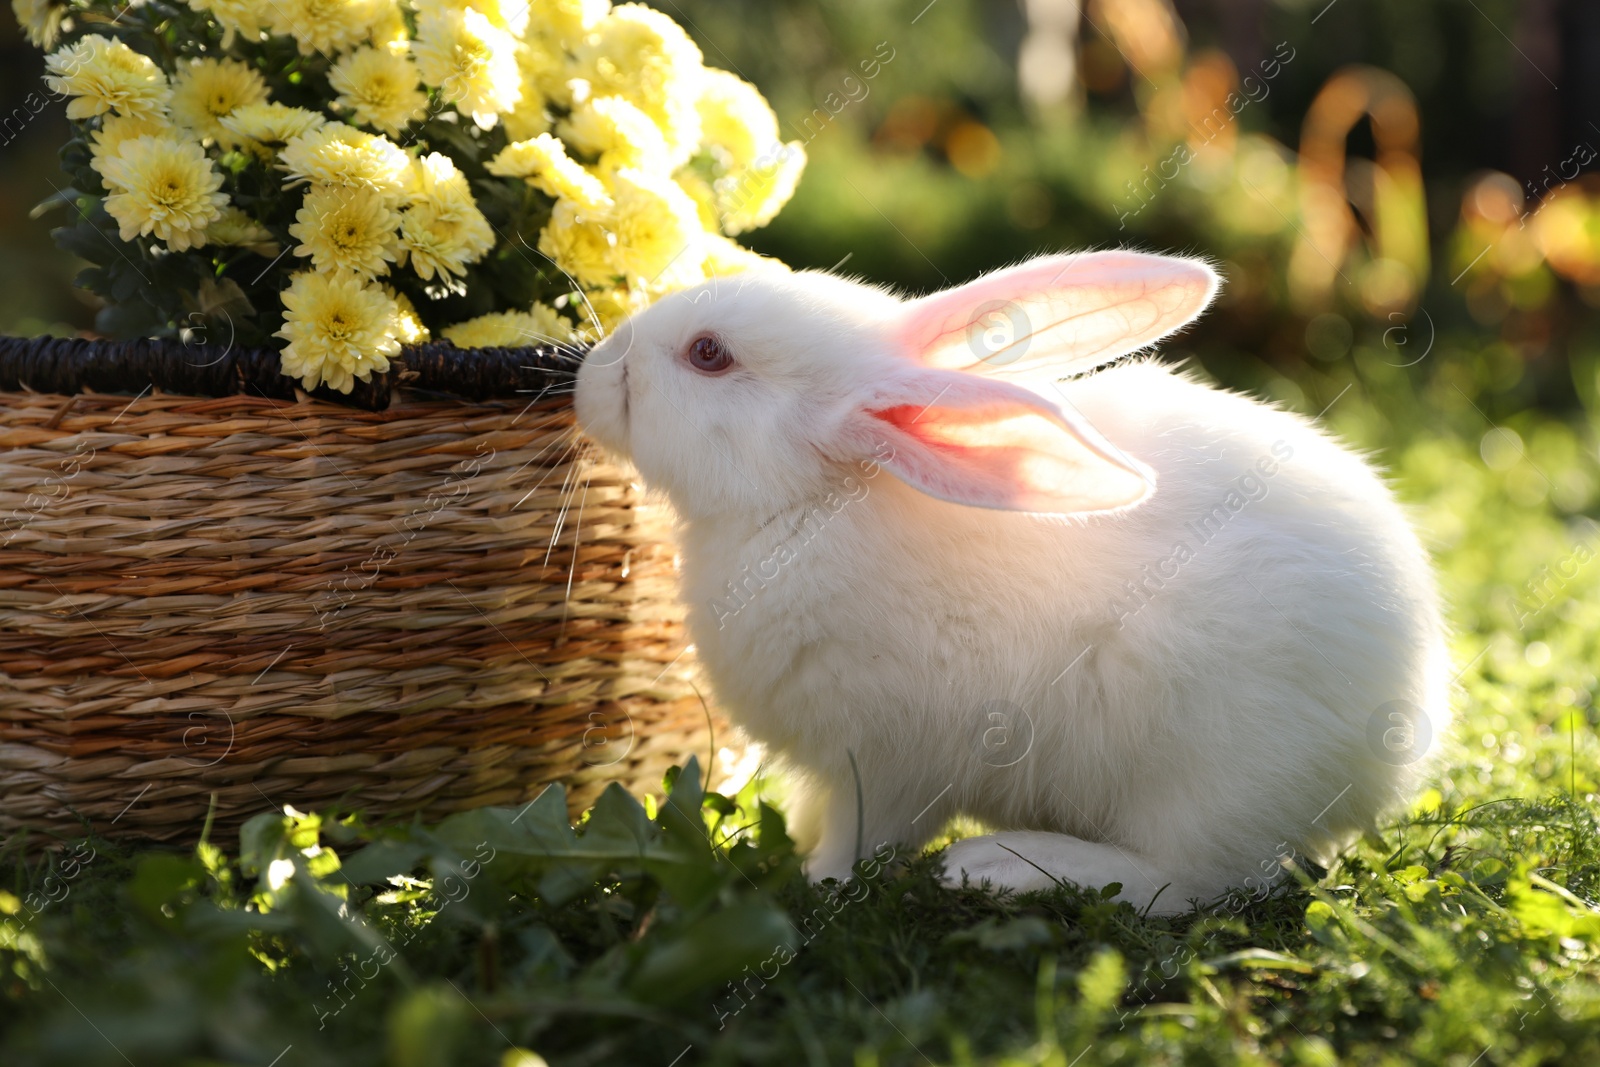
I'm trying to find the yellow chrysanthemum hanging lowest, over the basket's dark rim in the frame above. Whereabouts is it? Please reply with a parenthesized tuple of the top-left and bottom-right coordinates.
(274, 270, 400, 394)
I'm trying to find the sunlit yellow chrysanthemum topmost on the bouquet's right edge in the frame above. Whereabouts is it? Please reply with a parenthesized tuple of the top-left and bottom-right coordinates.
(578, 3, 706, 170)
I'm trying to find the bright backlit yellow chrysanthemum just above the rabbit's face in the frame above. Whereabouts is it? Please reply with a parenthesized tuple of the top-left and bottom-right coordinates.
(611, 170, 706, 291)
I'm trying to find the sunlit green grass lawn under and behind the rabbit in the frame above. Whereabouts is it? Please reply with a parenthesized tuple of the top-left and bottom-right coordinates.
(0, 346, 1600, 1067)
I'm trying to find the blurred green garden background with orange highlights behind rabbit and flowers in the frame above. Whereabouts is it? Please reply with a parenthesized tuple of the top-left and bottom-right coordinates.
(0, 0, 1600, 414)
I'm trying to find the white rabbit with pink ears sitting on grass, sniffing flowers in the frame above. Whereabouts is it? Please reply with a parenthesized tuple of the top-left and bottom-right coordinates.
(576, 251, 1450, 913)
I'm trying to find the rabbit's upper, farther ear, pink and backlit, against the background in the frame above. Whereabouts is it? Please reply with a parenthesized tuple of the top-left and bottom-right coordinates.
(896, 251, 1219, 378)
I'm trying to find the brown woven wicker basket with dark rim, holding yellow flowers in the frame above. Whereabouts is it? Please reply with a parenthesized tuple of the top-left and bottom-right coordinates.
(0, 339, 726, 841)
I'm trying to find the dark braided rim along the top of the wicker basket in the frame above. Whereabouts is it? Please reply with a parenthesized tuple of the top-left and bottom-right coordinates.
(0, 336, 584, 411)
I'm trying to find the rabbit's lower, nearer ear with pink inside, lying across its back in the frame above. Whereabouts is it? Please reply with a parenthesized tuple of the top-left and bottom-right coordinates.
(845, 368, 1155, 515)
